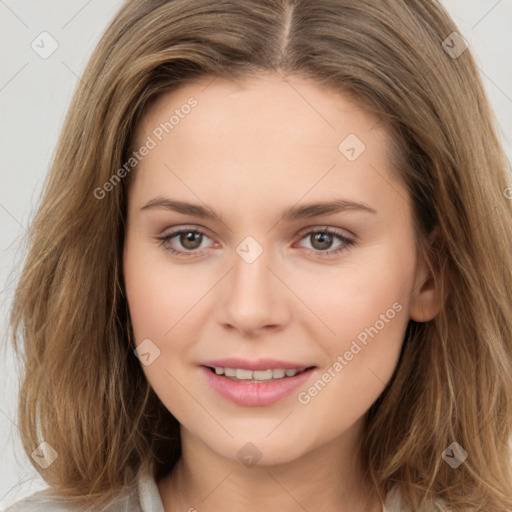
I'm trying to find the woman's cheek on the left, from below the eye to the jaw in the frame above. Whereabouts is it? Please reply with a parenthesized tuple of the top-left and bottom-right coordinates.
(123, 242, 208, 421)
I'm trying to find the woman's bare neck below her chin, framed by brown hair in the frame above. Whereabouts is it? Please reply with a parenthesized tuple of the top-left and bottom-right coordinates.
(158, 422, 382, 512)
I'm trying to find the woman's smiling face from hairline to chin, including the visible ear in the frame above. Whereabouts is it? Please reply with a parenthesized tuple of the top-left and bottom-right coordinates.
(124, 75, 432, 463)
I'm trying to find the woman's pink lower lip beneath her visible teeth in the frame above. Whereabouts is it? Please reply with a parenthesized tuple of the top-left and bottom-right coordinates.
(201, 366, 313, 407)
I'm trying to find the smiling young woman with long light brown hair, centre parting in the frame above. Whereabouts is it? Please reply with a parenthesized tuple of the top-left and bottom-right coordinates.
(7, 0, 512, 512)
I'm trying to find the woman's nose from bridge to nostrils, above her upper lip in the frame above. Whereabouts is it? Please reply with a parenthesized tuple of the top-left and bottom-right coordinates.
(217, 243, 290, 337)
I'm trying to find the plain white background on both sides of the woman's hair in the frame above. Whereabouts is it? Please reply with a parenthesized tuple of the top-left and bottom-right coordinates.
(0, 0, 512, 508)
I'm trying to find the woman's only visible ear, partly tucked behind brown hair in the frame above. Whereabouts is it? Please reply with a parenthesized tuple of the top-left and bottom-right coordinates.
(409, 227, 444, 322)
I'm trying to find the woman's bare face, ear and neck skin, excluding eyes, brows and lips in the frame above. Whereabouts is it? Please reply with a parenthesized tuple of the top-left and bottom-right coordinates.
(124, 74, 440, 512)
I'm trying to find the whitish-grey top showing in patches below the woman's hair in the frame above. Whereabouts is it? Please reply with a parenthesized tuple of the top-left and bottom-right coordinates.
(5, 471, 407, 512)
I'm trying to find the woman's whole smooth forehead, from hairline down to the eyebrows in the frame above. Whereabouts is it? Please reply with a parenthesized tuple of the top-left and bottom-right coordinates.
(129, 75, 408, 221)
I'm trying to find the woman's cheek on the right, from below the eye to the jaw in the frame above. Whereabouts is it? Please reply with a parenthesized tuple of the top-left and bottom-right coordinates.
(297, 237, 415, 396)
